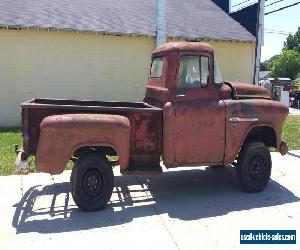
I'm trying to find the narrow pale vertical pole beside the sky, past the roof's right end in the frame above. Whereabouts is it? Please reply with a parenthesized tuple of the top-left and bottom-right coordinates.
(253, 0, 265, 85)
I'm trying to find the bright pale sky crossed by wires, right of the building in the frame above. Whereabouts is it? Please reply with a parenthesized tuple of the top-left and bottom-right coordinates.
(231, 0, 300, 61)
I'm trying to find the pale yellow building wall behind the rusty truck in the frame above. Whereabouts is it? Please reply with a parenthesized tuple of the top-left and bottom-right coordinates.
(0, 29, 255, 127)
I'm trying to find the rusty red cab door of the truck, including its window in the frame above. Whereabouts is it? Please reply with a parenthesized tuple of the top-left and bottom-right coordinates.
(173, 52, 225, 166)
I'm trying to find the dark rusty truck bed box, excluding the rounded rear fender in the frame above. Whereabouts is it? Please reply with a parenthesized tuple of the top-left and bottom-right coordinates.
(22, 99, 162, 159)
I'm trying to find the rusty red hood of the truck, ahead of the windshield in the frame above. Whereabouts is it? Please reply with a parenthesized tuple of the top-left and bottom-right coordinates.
(228, 82, 271, 99)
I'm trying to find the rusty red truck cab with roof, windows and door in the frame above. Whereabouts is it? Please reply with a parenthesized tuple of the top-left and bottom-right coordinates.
(144, 42, 227, 166)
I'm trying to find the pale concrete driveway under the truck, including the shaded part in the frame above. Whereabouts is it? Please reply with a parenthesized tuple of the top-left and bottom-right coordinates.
(0, 151, 300, 250)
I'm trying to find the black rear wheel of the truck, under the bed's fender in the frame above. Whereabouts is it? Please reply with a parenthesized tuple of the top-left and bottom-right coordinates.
(70, 153, 114, 212)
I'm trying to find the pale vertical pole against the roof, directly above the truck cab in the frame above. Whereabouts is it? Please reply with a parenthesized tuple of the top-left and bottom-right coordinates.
(155, 0, 167, 47)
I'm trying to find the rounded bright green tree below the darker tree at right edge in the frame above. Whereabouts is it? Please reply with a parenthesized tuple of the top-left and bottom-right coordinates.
(271, 50, 300, 80)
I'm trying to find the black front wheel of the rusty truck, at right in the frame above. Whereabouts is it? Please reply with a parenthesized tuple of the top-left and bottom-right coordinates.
(237, 142, 272, 193)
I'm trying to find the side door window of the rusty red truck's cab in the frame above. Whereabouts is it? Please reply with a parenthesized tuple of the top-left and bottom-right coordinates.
(177, 56, 209, 88)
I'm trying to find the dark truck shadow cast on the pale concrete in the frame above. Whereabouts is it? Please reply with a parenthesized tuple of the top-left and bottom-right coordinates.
(12, 167, 300, 233)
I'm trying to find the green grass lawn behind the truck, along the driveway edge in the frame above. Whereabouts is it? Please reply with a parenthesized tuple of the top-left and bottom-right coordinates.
(0, 116, 300, 175)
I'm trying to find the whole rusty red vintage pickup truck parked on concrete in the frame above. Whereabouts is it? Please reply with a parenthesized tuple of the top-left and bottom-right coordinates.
(16, 42, 288, 211)
